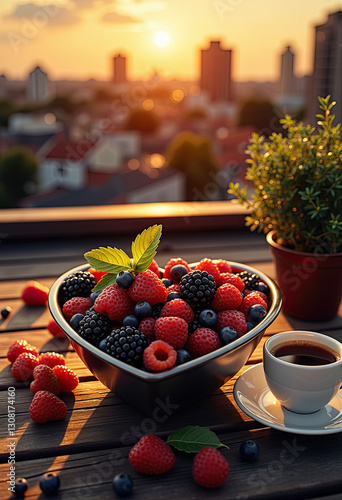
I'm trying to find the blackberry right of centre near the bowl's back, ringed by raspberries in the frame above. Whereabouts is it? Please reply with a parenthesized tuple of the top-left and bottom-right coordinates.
(180, 269, 215, 311)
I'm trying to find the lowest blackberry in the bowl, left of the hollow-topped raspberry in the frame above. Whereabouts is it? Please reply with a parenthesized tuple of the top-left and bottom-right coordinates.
(105, 326, 148, 367)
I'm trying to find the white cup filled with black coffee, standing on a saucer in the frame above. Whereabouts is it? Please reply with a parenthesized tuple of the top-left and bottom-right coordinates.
(263, 331, 342, 413)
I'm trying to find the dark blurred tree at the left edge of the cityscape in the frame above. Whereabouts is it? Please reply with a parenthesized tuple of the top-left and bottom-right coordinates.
(0, 147, 38, 208)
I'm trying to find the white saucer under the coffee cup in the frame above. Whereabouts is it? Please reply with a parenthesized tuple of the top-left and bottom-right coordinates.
(234, 363, 342, 435)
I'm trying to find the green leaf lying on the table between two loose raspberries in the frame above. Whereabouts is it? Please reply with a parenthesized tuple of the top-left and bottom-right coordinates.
(167, 425, 228, 453)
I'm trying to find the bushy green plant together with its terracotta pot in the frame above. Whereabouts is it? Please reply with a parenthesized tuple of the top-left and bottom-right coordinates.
(229, 96, 342, 320)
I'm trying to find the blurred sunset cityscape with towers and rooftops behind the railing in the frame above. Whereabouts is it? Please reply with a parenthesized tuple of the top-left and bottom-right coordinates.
(0, 0, 342, 209)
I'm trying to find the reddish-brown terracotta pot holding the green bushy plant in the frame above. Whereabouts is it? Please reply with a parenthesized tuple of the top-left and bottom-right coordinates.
(266, 231, 342, 321)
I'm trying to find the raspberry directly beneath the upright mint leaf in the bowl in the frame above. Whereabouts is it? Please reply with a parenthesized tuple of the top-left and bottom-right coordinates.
(127, 269, 167, 306)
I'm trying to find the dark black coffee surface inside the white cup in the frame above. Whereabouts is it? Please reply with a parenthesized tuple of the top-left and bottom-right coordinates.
(271, 340, 340, 366)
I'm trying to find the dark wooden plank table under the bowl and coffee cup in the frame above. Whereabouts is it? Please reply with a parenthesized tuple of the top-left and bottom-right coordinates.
(0, 262, 342, 500)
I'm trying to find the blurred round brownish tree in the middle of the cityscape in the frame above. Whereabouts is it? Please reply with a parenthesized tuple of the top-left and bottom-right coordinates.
(166, 132, 219, 201)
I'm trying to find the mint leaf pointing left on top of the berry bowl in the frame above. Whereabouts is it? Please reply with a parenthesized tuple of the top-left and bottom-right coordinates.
(84, 247, 132, 274)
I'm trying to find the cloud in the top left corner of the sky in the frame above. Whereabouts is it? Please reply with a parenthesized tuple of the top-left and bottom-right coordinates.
(4, 3, 80, 26)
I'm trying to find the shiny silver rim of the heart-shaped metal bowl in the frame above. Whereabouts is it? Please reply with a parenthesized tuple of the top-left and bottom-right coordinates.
(48, 260, 282, 382)
